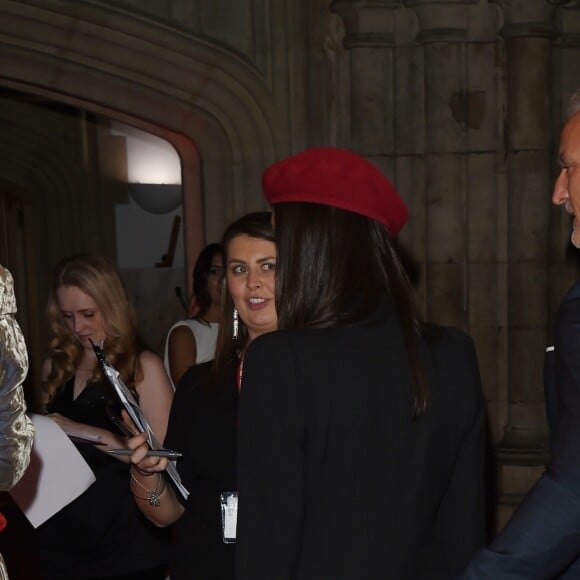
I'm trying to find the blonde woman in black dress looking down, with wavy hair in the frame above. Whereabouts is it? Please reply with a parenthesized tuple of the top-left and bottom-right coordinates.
(37, 255, 173, 580)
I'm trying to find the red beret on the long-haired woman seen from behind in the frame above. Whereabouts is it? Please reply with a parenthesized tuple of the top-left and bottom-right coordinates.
(262, 147, 409, 236)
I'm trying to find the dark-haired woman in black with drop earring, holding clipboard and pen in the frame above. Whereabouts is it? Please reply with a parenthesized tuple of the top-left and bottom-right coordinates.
(128, 212, 277, 580)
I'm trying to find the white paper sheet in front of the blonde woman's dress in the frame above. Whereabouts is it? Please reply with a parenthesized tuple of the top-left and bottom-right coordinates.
(9, 414, 95, 528)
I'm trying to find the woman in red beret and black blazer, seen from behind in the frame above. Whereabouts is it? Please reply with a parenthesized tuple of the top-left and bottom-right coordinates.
(237, 148, 485, 580)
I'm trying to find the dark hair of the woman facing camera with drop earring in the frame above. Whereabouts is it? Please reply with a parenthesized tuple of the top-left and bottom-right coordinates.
(212, 211, 275, 377)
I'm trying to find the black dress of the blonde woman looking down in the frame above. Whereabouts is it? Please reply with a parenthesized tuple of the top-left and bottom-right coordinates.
(37, 379, 169, 580)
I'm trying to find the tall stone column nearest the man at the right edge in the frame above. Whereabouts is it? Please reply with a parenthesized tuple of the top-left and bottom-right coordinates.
(494, 0, 556, 527)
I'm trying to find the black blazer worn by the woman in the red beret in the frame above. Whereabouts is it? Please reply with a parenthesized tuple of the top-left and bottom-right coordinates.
(236, 308, 484, 580)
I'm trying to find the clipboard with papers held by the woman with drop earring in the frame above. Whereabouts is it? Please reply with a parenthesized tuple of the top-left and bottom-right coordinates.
(91, 341, 189, 499)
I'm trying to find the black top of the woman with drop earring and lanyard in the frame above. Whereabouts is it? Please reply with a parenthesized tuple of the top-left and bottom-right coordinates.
(165, 361, 238, 580)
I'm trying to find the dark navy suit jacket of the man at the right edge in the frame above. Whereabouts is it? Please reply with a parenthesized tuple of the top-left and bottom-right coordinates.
(462, 282, 580, 580)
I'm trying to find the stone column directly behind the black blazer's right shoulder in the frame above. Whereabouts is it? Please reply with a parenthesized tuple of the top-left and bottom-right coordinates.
(404, 0, 484, 328)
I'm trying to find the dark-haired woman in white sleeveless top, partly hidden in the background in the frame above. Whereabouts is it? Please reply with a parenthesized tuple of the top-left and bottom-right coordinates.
(163, 244, 222, 388)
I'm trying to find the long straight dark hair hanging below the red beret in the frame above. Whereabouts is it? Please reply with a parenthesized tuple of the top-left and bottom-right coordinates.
(274, 203, 427, 416)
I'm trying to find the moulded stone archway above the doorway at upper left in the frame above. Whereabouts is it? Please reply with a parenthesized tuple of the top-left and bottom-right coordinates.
(0, 2, 284, 268)
